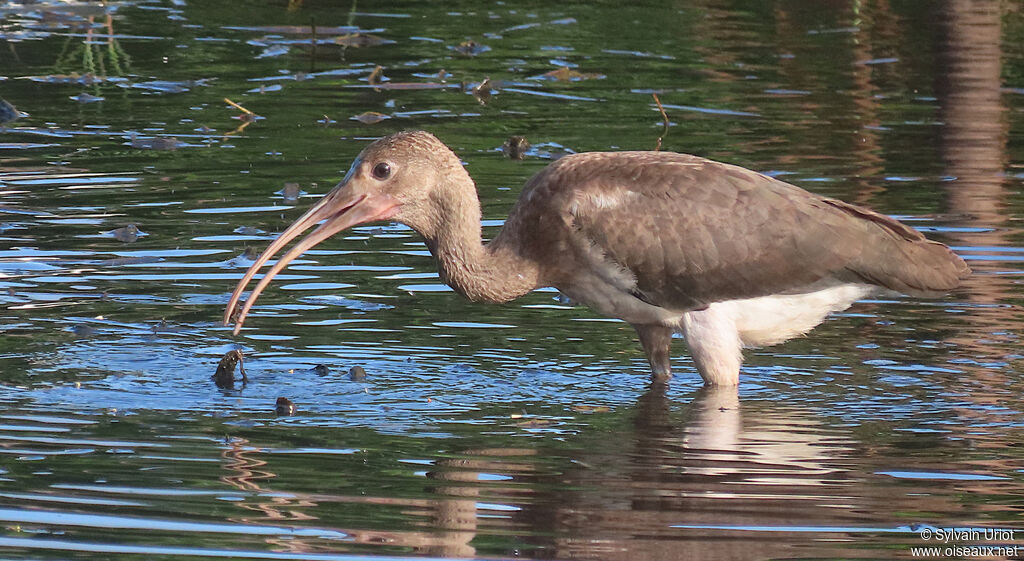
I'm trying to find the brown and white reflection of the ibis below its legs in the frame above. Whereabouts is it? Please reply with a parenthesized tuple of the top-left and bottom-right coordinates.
(523, 384, 897, 559)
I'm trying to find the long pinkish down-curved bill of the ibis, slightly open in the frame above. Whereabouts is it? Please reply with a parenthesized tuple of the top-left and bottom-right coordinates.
(224, 183, 397, 335)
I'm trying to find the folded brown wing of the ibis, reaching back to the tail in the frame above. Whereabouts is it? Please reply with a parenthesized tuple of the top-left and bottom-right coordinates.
(544, 153, 969, 309)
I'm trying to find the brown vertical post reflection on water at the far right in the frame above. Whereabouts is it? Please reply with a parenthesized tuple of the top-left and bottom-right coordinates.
(936, 0, 1021, 378)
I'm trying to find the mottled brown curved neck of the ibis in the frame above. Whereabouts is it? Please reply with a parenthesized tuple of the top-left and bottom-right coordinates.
(421, 177, 540, 302)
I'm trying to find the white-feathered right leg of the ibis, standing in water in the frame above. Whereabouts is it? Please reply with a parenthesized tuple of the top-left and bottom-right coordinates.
(683, 304, 743, 386)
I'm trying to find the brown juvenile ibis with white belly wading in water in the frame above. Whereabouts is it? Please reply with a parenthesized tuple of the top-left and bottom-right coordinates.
(224, 131, 971, 385)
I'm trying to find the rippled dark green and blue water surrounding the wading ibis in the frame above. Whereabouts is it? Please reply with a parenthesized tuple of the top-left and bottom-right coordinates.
(0, 0, 1024, 559)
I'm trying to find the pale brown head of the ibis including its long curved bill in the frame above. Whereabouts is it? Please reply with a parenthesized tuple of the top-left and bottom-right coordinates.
(224, 131, 469, 334)
